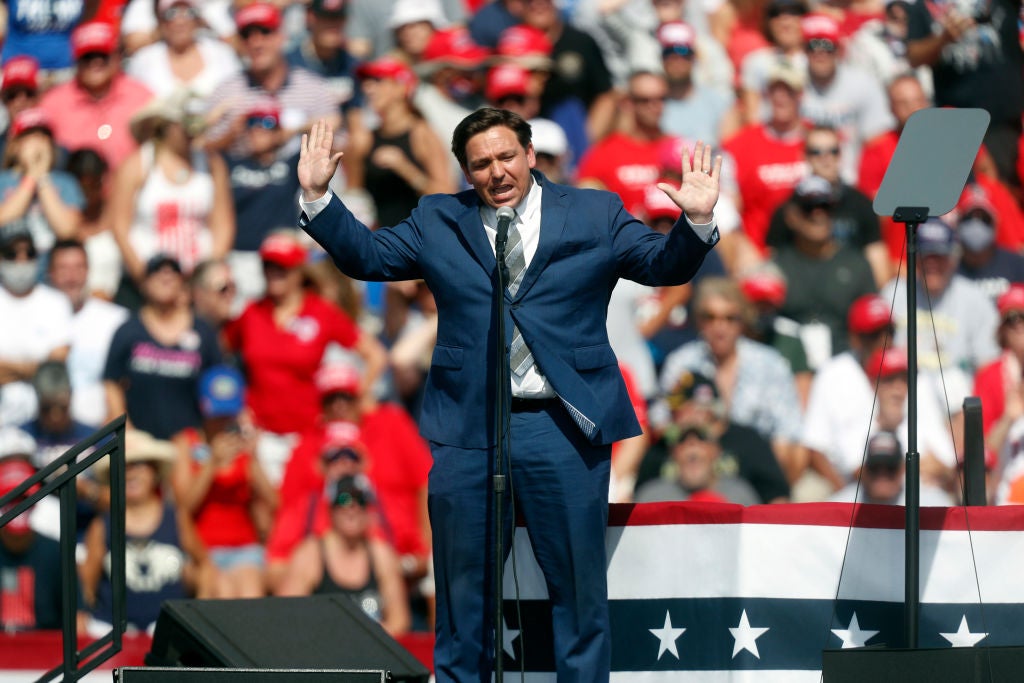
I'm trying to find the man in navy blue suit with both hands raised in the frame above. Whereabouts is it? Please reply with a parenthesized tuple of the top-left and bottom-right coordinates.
(298, 109, 722, 683)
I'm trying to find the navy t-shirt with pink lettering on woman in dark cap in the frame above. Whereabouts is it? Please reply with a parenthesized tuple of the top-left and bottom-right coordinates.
(103, 313, 220, 439)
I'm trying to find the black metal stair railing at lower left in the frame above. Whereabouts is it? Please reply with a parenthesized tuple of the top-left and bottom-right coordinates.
(0, 416, 126, 683)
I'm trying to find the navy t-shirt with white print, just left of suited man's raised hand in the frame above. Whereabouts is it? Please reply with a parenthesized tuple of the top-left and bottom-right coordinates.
(227, 153, 299, 252)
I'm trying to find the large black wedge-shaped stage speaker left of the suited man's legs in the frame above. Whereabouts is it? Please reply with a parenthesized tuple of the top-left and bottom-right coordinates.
(145, 595, 430, 683)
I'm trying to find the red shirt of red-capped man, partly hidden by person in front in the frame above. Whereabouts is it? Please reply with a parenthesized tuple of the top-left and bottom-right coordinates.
(267, 403, 433, 559)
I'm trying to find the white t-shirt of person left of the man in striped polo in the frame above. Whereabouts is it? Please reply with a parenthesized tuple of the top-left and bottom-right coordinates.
(125, 37, 242, 97)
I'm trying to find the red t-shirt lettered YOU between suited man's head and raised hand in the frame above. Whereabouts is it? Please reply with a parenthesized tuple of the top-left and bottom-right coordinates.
(577, 133, 665, 216)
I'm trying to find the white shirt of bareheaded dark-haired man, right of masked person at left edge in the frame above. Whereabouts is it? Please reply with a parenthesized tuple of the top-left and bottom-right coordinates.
(68, 298, 128, 427)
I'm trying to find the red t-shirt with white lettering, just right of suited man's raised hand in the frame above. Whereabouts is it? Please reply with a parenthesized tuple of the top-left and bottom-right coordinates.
(722, 124, 808, 251)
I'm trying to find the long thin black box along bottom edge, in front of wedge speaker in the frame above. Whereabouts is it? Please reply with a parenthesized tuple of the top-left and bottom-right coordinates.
(114, 667, 390, 683)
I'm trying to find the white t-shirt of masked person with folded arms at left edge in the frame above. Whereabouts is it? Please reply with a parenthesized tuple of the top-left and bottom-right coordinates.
(0, 285, 72, 425)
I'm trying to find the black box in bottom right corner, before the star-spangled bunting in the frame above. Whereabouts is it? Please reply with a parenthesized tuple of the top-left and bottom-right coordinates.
(821, 645, 1024, 683)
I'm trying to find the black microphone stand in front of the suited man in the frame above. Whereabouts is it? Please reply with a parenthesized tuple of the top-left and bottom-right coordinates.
(492, 211, 511, 683)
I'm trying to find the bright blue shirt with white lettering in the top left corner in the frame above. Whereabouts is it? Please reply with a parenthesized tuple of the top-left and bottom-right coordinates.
(0, 0, 85, 69)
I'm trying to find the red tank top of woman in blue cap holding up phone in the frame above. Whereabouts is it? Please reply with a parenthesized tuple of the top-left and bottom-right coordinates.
(185, 429, 259, 548)
